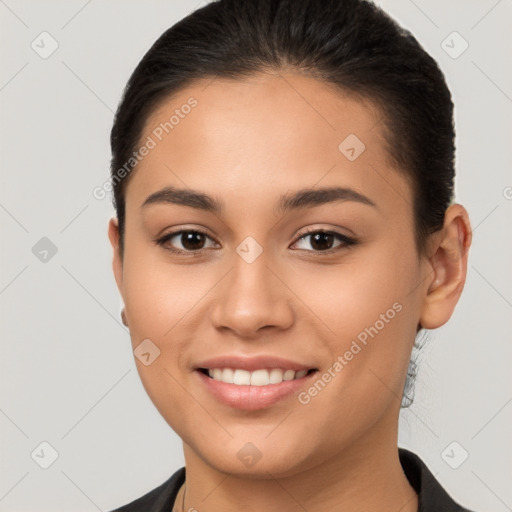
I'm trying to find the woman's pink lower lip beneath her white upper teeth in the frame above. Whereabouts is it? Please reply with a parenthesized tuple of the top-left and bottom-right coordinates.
(196, 370, 317, 411)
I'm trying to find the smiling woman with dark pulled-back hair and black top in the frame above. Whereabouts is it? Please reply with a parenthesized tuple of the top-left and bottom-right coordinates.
(109, 0, 471, 512)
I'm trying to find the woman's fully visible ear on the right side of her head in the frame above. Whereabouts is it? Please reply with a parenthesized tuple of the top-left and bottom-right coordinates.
(420, 204, 472, 329)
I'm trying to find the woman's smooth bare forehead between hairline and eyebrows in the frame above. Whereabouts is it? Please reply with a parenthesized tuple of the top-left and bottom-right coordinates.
(127, 73, 409, 214)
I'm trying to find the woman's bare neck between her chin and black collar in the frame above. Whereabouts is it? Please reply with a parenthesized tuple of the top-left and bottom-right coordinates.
(175, 412, 418, 512)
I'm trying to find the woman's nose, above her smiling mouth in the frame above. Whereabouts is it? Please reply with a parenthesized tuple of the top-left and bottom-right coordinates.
(211, 251, 295, 339)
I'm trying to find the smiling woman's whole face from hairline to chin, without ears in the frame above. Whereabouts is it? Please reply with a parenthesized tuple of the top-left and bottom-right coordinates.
(110, 73, 436, 478)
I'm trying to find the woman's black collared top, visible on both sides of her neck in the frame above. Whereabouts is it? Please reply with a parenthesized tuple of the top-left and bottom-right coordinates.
(112, 448, 471, 512)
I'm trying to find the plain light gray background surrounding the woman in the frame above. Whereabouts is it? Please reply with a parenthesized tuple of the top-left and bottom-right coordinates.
(0, 0, 512, 512)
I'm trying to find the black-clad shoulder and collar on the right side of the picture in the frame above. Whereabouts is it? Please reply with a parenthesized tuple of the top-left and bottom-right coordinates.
(398, 448, 473, 512)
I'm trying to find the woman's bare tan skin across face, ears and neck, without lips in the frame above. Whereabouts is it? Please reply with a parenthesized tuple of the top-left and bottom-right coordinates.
(108, 72, 471, 512)
